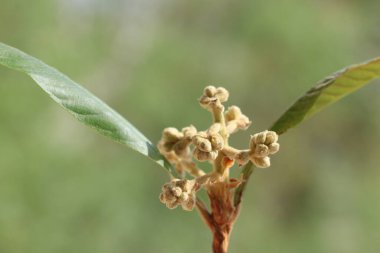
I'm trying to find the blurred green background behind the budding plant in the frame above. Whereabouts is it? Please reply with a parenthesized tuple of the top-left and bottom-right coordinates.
(0, 0, 380, 253)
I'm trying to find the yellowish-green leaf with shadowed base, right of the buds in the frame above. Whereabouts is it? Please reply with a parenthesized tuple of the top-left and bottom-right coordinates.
(270, 58, 380, 134)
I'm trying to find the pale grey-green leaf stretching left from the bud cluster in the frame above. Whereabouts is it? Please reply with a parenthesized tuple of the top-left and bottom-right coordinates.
(0, 43, 172, 173)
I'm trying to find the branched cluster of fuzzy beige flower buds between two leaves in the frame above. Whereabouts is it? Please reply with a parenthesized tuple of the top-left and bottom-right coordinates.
(157, 86, 280, 210)
